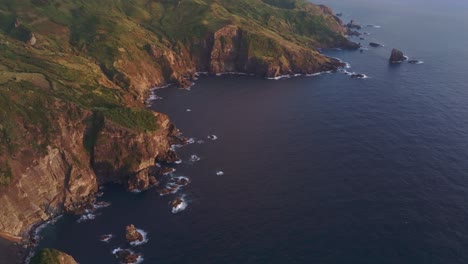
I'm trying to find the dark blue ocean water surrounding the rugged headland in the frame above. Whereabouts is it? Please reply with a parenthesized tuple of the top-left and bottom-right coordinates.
(34, 0, 468, 264)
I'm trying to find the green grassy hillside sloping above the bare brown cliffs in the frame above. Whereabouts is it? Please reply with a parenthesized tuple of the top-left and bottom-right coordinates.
(0, 0, 352, 185)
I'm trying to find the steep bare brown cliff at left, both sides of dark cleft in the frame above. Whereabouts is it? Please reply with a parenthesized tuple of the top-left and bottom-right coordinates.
(0, 105, 177, 238)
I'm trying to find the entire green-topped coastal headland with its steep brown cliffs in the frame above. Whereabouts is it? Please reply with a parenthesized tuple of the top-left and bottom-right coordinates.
(0, 0, 357, 248)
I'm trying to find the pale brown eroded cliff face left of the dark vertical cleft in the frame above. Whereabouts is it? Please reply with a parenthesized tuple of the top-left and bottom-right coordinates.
(0, 105, 97, 236)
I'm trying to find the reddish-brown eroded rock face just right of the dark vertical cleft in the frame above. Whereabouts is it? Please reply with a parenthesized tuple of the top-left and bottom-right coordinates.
(93, 113, 178, 187)
